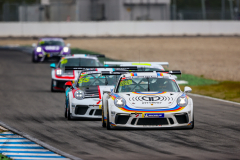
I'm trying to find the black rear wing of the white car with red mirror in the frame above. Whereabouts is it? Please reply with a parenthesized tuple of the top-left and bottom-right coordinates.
(65, 66, 138, 70)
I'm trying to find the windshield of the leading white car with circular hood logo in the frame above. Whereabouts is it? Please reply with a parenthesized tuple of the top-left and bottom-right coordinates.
(117, 78, 179, 93)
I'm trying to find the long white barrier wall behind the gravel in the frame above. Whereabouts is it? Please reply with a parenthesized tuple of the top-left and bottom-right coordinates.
(0, 21, 240, 37)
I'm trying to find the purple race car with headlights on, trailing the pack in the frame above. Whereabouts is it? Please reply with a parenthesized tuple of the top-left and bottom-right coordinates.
(32, 38, 71, 62)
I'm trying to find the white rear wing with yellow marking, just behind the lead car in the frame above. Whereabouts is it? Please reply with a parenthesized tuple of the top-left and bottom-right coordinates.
(104, 61, 169, 66)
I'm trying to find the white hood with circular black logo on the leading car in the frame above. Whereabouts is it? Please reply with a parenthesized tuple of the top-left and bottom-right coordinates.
(118, 92, 182, 108)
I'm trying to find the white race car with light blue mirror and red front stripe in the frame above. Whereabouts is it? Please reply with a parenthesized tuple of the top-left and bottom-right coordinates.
(50, 54, 102, 92)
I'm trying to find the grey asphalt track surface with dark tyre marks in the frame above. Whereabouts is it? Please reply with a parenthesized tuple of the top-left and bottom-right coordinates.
(0, 50, 240, 160)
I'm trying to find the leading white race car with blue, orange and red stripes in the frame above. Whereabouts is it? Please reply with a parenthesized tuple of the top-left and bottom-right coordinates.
(102, 71, 194, 129)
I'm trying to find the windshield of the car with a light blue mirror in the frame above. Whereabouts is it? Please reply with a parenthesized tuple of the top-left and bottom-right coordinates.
(59, 58, 100, 68)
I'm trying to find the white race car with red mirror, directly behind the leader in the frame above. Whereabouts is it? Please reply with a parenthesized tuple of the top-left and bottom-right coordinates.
(65, 67, 135, 120)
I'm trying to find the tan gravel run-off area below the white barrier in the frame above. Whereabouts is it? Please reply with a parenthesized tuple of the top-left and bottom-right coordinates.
(0, 37, 240, 81)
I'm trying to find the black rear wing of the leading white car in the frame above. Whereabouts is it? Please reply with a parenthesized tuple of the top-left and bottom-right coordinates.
(102, 70, 182, 75)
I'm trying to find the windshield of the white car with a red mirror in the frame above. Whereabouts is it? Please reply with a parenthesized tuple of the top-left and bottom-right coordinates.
(78, 73, 120, 87)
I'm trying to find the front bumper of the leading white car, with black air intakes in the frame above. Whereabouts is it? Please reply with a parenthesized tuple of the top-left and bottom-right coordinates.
(109, 109, 193, 128)
